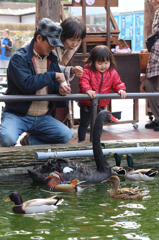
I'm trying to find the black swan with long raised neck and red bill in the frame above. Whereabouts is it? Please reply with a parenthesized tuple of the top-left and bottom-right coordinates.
(28, 110, 112, 183)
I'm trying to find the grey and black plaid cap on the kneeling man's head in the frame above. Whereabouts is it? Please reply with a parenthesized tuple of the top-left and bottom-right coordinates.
(36, 18, 64, 47)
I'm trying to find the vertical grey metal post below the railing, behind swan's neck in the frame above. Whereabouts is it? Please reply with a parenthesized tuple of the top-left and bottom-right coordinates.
(90, 98, 98, 142)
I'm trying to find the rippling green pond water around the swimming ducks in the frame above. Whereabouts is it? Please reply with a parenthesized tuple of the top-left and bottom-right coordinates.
(0, 174, 159, 240)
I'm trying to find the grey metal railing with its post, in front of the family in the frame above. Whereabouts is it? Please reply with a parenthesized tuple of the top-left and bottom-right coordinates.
(0, 93, 159, 141)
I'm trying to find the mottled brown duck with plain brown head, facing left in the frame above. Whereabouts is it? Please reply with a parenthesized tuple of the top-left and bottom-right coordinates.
(101, 175, 144, 199)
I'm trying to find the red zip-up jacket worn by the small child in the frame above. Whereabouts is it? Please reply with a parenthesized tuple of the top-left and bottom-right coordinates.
(78, 64, 126, 107)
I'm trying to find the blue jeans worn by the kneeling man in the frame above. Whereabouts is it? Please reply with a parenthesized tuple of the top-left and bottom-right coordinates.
(0, 112, 72, 147)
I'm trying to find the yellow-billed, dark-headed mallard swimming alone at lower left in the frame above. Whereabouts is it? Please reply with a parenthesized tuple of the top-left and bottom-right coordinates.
(5, 192, 64, 213)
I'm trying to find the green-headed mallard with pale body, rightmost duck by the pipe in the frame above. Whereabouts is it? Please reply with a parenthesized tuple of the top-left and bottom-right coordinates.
(123, 154, 158, 181)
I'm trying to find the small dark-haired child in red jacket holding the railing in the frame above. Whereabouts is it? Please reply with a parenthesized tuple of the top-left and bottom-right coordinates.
(78, 45, 126, 142)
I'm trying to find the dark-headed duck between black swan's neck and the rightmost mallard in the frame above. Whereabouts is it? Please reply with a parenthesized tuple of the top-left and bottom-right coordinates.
(110, 152, 126, 176)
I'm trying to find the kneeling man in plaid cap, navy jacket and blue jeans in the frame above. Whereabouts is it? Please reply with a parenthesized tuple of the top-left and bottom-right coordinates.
(0, 18, 72, 147)
